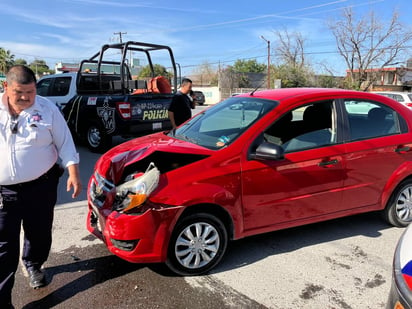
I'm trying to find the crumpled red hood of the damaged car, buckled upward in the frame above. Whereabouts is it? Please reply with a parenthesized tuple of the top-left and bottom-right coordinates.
(95, 132, 214, 184)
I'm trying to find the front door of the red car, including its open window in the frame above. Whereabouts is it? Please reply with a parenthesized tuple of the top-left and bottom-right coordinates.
(241, 101, 345, 234)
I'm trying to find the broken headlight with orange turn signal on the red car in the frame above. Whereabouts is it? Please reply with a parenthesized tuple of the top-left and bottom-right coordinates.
(113, 162, 160, 212)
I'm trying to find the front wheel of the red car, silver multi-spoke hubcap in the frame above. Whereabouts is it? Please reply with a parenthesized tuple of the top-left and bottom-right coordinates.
(166, 213, 228, 276)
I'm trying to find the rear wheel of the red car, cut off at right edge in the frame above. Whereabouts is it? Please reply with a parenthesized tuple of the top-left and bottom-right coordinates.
(383, 179, 412, 227)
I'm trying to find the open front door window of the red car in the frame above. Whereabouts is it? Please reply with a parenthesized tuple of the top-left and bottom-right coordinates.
(264, 101, 336, 152)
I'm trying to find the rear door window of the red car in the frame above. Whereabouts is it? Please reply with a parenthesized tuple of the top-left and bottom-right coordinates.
(344, 100, 400, 141)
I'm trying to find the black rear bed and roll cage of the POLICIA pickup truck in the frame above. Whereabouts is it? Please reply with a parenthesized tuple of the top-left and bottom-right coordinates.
(48, 41, 177, 152)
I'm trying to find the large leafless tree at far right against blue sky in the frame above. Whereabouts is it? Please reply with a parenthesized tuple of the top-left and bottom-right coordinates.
(329, 8, 412, 90)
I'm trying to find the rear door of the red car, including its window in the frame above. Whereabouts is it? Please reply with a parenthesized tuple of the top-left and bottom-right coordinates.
(343, 99, 412, 209)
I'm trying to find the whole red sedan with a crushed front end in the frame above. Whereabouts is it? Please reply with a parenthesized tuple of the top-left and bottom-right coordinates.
(87, 88, 412, 275)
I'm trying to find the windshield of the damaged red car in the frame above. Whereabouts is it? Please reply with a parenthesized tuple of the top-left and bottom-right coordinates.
(168, 97, 278, 150)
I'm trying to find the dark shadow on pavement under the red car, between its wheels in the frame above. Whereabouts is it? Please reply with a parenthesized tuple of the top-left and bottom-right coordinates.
(212, 212, 393, 273)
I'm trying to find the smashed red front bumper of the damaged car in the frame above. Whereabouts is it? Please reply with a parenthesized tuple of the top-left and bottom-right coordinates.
(87, 166, 182, 263)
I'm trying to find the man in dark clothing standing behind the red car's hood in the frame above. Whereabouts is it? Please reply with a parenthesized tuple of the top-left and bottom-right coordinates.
(169, 78, 195, 129)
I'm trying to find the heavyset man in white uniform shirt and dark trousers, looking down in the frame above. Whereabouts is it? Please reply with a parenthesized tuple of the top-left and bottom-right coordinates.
(0, 65, 81, 308)
